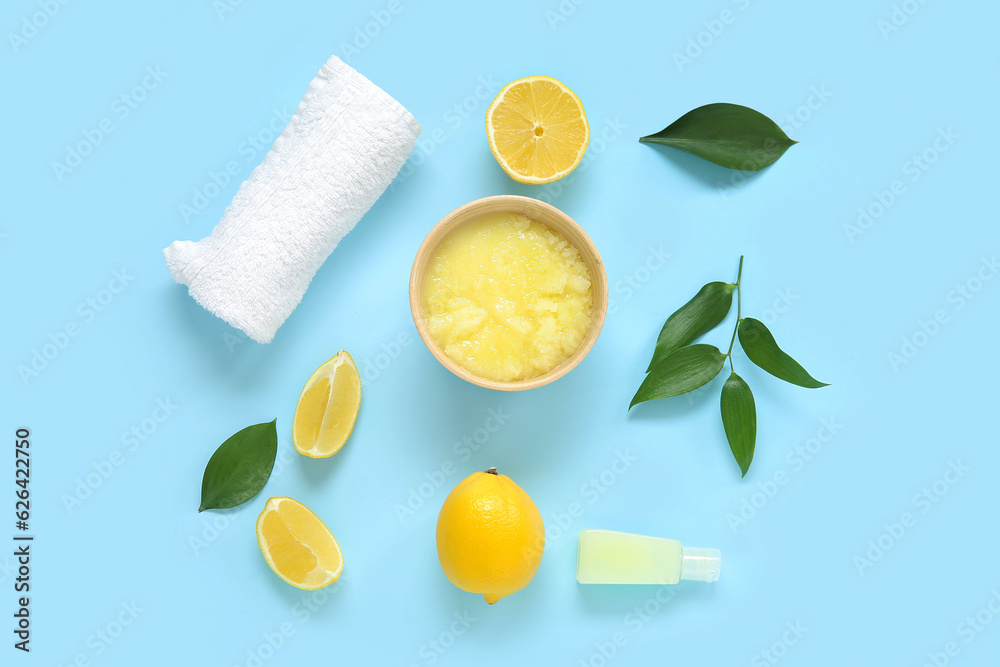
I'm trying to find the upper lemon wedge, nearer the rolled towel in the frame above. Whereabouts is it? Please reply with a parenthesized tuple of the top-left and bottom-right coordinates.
(292, 350, 361, 459)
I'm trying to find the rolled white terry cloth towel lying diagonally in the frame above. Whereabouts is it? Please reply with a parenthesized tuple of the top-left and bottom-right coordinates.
(163, 56, 420, 343)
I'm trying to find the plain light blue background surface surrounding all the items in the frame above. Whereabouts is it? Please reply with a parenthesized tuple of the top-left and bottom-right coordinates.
(0, 0, 1000, 667)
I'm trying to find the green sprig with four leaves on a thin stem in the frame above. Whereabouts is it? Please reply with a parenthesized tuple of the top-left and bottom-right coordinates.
(629, 256, 827, 477)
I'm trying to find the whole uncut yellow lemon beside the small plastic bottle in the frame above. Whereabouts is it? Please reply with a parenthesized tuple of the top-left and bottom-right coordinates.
(437, 468, 545, 604)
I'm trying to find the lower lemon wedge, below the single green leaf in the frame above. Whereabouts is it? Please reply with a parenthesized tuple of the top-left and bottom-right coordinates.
(257, 497, 344, 591)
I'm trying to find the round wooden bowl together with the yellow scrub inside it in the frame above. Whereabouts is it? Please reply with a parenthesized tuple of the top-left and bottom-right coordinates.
(410, 195, 608, 391)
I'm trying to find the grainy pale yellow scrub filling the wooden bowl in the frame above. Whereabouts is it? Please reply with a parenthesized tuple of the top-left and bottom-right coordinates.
(423, 213, 594, 382)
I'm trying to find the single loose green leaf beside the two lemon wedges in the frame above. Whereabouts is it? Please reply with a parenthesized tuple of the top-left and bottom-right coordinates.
(198, 419, 278, 512)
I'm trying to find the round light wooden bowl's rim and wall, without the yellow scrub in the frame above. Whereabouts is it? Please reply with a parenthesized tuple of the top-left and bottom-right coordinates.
(410, 195, 608, 391)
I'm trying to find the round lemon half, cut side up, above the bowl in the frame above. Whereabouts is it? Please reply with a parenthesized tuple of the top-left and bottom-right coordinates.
(486, 76, 590, 183)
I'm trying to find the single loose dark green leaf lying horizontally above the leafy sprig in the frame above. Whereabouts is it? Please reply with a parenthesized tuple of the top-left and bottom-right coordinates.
(639, 103, 798, 171)
